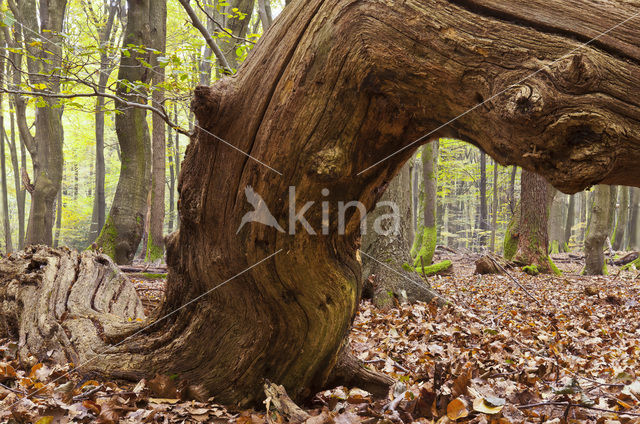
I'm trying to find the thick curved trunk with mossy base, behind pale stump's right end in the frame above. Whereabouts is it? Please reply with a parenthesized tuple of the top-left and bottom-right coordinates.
(96, 0, 151, 264)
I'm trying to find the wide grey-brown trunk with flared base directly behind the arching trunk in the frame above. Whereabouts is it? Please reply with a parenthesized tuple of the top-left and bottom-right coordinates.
(360, 162, 434, 308)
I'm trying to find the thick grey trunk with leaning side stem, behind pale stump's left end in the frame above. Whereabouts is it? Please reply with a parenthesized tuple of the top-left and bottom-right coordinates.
(10, 0, 67, 245)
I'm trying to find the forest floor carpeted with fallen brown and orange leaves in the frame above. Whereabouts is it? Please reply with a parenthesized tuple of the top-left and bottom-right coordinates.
(0, 251, 640, 424)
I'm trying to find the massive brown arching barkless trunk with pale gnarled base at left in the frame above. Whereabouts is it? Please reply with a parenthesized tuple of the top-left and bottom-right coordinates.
(2, 0, 640, 405)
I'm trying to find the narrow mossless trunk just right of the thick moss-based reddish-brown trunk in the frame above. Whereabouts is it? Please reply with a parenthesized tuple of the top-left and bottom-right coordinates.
(584, 185, 612, 275)
